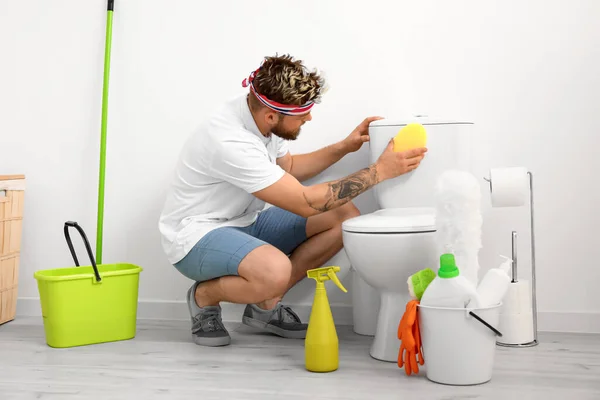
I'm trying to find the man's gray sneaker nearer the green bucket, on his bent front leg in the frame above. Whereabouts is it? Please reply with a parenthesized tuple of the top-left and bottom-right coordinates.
(187, 282, 231, 346)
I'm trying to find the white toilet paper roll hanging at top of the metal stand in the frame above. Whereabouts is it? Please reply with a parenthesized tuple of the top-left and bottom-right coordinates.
(490, 167, 529, 207)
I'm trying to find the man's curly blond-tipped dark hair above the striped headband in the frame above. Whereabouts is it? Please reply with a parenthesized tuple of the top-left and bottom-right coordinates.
(248, 54, 326, 106)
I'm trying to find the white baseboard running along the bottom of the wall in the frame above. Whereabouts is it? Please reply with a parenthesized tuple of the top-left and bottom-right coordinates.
(17, 297, 600, 333)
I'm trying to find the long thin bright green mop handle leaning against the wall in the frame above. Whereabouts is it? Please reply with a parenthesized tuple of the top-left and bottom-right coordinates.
(96, 0, 115, 264)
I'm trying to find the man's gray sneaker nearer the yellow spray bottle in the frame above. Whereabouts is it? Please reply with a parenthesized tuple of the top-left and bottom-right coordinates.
(242, 303, 308, 339)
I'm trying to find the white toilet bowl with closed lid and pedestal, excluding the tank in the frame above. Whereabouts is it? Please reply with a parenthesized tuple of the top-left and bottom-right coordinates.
(342, 208, 437, 362)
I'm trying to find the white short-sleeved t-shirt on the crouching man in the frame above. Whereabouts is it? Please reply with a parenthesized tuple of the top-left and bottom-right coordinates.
(159, 94, 288, 264)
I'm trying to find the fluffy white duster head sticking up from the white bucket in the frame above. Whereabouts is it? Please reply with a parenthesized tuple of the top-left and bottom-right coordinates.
(435, 170, 482, 286)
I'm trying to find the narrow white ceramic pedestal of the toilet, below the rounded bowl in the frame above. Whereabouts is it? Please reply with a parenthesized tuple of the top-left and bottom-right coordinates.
(369, 292, 410, 362)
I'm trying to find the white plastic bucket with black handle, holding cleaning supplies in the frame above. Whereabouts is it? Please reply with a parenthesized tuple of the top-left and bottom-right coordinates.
(418, 304, 502, 385)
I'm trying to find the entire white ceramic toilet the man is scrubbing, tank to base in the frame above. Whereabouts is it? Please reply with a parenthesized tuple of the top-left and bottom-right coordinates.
(342, 117, 473, 362)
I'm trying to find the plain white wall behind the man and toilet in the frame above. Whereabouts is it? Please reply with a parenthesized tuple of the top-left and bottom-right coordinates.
(0, 0, 600, 330)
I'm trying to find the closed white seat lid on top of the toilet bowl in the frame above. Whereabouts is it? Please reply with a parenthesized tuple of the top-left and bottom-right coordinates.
(342, 208, 435, 233)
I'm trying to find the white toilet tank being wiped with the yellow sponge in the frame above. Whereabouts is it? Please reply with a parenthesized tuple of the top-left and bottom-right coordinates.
(369, 117, 474, 208)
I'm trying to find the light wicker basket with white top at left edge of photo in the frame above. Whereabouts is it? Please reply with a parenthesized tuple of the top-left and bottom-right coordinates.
(0, 175, 25, 324)
